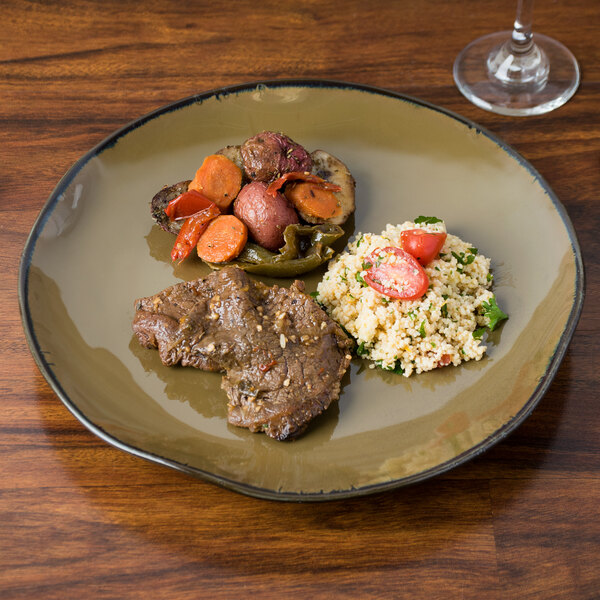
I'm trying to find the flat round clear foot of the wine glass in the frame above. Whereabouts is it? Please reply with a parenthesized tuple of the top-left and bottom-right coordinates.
(453, 31, 580, 117)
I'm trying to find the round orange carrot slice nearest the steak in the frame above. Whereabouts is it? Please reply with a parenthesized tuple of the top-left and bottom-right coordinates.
(197, 215, 248, 263)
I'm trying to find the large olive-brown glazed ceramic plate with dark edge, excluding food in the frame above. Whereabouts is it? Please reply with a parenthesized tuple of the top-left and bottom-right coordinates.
(20, 81, 583, 500)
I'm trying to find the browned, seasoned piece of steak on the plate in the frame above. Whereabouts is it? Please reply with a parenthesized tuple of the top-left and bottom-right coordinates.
(133, 266, 353, 440)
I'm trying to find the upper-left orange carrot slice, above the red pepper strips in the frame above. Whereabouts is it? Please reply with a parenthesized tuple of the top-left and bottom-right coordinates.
(188, 154, 242, 210)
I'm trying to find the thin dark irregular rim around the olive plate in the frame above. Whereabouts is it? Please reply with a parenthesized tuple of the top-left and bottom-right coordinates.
(18, 78, 585, 502)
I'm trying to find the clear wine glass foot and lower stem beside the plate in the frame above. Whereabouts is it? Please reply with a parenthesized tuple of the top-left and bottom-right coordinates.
(453, 0, 579, 116)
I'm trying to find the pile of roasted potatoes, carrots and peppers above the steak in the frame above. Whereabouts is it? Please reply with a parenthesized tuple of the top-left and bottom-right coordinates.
(151, 131, 355, 277)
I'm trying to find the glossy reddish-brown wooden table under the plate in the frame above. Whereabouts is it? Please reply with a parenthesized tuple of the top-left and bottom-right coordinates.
(0, 0, 600, 600)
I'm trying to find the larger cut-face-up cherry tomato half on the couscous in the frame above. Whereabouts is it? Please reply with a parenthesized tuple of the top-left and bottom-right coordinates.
(364, 246, 429, 300)
